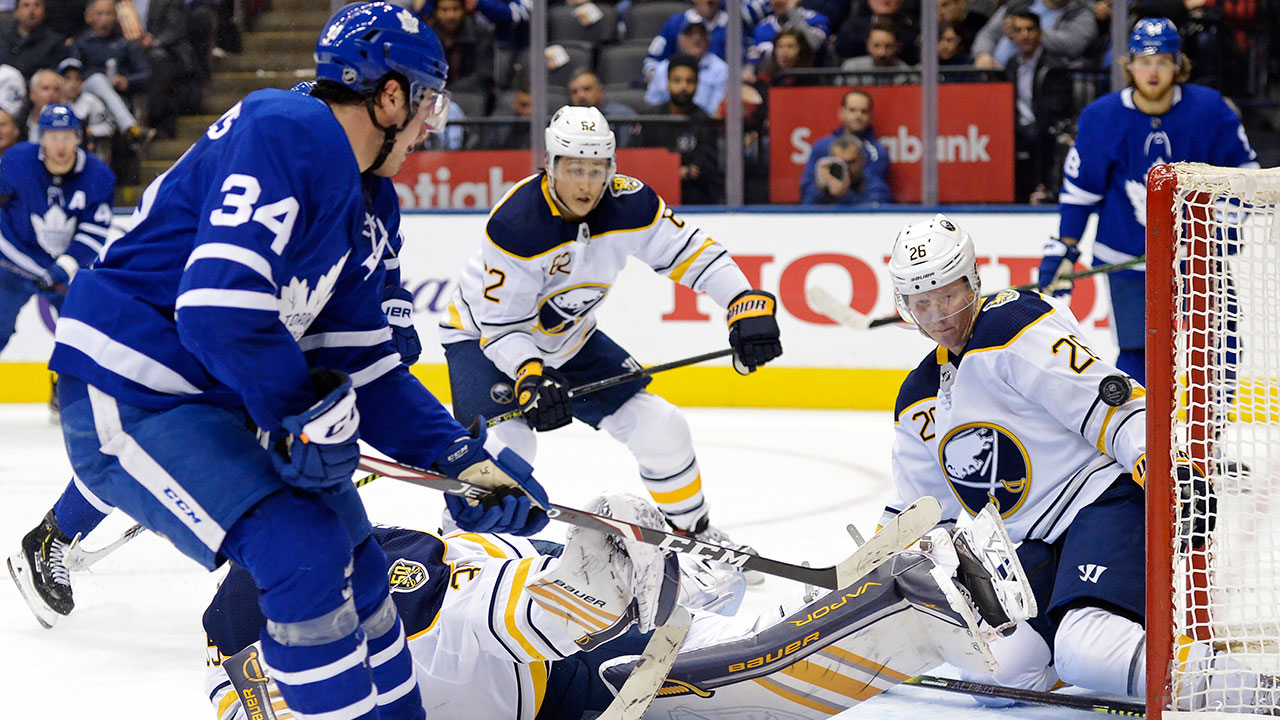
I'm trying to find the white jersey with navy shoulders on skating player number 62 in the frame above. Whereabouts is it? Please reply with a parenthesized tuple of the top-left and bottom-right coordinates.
(440, 173, 751, 377)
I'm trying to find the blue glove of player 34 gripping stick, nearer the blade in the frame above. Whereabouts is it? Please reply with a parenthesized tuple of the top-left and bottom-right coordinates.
(435, 421, 549, 536)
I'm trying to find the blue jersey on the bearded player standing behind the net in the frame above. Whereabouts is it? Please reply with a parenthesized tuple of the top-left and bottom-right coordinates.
(1059, 85, 1258, 263)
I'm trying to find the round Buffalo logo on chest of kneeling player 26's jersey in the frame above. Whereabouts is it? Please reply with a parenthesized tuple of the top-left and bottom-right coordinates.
(938, 423, 1032, 518)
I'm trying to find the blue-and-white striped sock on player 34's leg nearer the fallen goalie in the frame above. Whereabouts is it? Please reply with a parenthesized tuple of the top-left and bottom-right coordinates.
(352, 537, 426, 720)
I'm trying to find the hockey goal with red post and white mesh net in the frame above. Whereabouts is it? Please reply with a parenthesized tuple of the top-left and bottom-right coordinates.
(1146, 163, 1280, 717)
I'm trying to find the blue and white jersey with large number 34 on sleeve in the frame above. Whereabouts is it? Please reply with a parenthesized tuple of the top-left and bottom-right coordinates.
(50, 90, 465, 466)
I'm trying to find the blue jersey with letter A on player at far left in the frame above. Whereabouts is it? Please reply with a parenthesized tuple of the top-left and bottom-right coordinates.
(0, 142, 115, 283)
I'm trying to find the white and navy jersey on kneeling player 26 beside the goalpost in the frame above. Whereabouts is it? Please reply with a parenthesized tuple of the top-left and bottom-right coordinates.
(884, 290, 1147, 542)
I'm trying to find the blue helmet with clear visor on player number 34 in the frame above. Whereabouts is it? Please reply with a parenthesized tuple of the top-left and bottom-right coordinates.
(315, 1, 449, 119)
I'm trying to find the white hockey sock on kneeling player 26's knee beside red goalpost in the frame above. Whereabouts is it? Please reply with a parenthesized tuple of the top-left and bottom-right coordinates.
(1053, 606, 1147, 697)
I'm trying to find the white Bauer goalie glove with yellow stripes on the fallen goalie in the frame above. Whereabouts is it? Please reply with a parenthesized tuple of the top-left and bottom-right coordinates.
(527, 495, 680, 650)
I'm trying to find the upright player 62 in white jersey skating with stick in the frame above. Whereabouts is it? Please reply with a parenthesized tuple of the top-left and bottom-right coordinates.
(440, 106, 782, 542)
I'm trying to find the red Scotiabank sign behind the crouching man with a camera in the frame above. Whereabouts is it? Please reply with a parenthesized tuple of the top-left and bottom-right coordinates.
(769, 82, 1014, 202)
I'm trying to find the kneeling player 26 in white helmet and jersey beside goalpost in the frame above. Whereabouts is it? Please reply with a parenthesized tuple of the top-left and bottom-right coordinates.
(884, 214, 1275, 710)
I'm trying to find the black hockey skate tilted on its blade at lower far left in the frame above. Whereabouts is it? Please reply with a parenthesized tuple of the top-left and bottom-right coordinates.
(9, 510, 76, 628)
